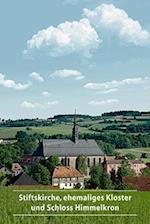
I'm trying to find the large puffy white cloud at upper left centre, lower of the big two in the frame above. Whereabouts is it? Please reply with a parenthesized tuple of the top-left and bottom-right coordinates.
(24, 19, 102, 57)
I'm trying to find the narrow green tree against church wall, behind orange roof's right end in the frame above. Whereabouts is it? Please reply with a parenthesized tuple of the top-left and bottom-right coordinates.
(76, 156, 87, 175)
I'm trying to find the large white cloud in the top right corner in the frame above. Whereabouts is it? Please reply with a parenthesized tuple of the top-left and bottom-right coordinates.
(83, 4, 150, 46)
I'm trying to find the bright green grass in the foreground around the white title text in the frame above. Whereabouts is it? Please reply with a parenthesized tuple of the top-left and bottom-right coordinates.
(0, 187, 150, 224)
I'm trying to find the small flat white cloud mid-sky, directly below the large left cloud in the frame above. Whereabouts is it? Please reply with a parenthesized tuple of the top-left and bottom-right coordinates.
(50, 69, 85, 80)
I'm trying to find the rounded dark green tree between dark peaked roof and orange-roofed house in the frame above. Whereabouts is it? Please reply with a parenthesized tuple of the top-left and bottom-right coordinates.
(31, 163, 50, 185)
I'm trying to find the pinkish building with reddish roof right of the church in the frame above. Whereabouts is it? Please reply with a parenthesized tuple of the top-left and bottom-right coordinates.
(103, 159, 146, 175)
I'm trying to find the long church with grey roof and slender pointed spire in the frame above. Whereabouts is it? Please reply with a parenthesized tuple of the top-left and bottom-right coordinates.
(33, 115, 104, 168)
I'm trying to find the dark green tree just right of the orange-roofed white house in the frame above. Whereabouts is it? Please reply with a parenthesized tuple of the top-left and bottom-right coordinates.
(90, 165, 103, 189)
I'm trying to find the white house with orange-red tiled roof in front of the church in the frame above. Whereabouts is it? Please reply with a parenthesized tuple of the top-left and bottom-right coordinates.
(52, 166, 84, 189)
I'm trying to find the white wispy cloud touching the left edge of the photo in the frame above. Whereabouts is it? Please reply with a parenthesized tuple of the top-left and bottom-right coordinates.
(0, 73, 31, 90)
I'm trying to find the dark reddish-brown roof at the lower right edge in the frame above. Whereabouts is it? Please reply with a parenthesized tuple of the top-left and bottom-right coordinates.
(123, 177, 150, 191)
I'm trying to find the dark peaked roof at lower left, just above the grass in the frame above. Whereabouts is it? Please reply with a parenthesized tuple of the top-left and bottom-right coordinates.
(9, 173, 38, 186)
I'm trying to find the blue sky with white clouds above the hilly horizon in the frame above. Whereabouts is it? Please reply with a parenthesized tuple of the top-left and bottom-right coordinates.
(0, 0, 150, 119)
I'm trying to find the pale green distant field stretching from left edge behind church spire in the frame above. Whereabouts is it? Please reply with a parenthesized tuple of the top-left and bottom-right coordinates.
(0, 124, 92, 139)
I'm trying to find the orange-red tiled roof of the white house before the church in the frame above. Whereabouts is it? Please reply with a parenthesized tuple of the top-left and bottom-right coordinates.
(53, 166, 83, 178)
